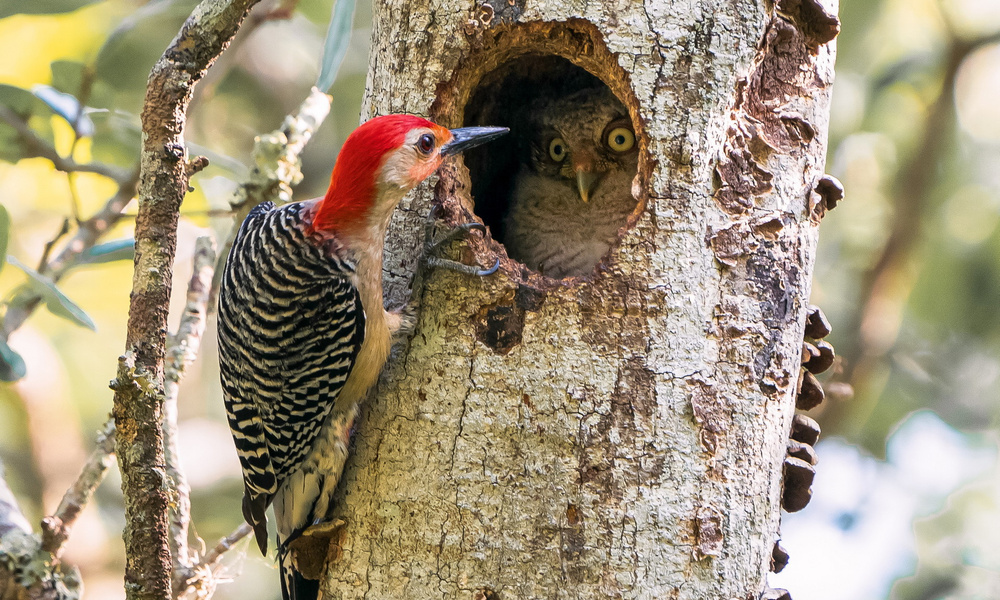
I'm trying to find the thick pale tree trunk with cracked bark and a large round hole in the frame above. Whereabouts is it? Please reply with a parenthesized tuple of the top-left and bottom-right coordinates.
(324, 0, 839, 600)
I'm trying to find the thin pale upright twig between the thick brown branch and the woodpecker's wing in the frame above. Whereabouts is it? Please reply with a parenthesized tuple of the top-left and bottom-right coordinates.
(163, 236, 215, 595)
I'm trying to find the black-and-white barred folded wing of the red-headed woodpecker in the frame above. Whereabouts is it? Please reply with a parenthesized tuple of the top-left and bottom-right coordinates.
(219, 203, 365, 552)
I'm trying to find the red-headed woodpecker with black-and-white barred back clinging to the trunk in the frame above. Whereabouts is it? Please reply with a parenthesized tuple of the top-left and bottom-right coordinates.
(218, 115, 507, 600)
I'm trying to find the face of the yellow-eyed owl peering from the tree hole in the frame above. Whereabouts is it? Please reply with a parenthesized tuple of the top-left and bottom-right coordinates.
(527, 87, 639, 202)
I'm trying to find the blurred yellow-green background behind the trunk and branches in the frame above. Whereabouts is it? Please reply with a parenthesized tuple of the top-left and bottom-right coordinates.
(0, 0, 1000, 600)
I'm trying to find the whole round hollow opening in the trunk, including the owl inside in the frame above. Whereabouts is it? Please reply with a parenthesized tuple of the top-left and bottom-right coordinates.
(465, 55, 639, 279)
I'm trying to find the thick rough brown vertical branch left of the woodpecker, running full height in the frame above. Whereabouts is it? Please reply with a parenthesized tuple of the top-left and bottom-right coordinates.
(113, 0, 257, 600)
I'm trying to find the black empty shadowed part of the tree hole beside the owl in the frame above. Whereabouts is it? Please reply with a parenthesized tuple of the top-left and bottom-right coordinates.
(463, 54, 605, 243)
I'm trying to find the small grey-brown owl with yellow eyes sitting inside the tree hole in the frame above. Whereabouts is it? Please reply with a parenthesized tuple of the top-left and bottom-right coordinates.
(503, 86, 639, 278)
